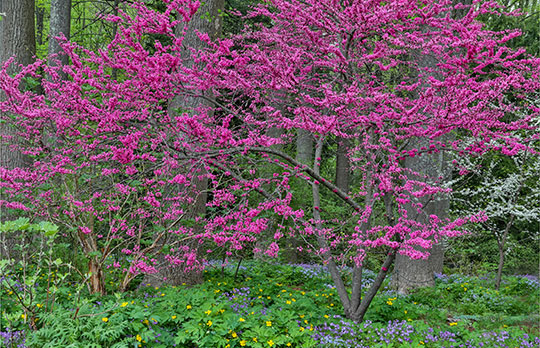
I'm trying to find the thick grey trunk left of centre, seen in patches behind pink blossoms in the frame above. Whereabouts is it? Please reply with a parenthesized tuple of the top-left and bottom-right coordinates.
(144, 0, 225, 286)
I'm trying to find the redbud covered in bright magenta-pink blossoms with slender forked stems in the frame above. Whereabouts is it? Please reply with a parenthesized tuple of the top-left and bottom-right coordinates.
(0, 0, 540, 321)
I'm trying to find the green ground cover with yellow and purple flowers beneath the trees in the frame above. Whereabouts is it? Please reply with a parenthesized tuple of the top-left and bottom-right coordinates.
(2, 261, 540, 348)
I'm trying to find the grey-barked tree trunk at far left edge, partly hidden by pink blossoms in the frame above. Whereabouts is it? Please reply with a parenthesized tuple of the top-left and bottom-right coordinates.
(0, 0, 36, 258)
